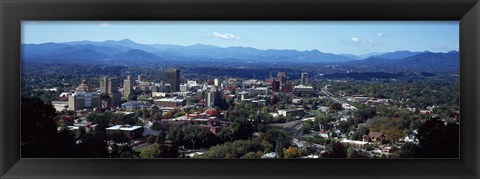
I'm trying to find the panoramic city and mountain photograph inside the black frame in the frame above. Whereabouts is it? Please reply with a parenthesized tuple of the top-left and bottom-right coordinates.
(20, 20, 460, 160)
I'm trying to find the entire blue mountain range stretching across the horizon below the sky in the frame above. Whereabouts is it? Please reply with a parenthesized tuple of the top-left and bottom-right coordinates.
(21, 39, 459, 71)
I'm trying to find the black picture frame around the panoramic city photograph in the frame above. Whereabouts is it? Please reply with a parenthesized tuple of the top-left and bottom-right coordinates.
(0, 0, 480, 178)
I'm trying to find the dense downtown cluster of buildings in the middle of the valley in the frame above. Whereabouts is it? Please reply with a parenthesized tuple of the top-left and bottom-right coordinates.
(52, 69, 317, 116)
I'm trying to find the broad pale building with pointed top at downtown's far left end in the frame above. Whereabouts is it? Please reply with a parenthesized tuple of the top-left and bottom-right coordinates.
(68, 80, 101, 111)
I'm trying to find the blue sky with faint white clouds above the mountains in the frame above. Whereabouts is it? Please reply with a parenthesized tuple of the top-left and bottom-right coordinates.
(22, 21, 459, 55)
